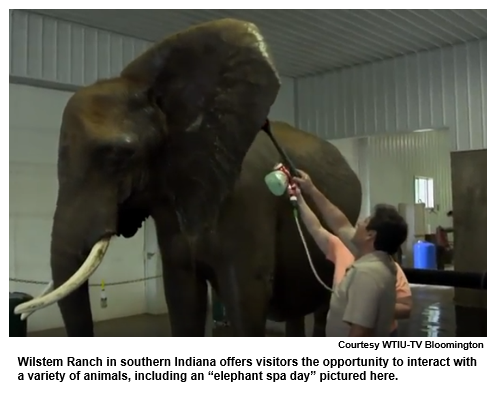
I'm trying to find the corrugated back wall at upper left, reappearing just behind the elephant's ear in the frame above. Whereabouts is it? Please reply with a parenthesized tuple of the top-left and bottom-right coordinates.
(9, 10, 295, 124)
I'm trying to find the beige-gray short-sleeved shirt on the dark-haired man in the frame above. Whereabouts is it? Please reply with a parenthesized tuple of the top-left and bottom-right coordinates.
(332, 251, 397, 337)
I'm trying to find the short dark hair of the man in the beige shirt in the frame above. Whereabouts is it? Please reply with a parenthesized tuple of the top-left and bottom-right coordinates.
(366, 204, 408, 255)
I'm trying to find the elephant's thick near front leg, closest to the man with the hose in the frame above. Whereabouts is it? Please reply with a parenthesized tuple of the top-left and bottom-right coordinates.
(215, 210, 275, 336)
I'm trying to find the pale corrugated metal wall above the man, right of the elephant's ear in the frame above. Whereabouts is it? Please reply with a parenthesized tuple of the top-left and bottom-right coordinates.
(296, 40, 487, 150)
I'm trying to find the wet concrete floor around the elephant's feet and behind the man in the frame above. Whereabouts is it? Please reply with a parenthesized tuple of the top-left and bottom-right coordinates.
(28, 286, 487, 337)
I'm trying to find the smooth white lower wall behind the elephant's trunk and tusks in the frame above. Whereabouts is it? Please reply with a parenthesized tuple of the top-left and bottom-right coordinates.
(9, 84, 165, 331)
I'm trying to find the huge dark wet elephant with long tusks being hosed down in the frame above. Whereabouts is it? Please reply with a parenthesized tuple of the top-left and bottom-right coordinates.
(15, 19, 361, 336)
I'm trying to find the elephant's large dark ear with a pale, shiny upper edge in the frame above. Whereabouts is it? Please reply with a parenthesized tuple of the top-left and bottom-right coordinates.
(121, 19, 280, 232)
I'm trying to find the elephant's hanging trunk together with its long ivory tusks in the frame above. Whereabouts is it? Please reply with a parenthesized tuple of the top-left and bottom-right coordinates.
(15, 187, 117, 336)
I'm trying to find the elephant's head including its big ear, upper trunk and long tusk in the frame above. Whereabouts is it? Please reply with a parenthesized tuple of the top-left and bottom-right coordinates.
(16, 19, 280, 327)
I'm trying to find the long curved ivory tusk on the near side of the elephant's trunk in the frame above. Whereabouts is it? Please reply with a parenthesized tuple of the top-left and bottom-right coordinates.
(14, 239, 110, 314)
